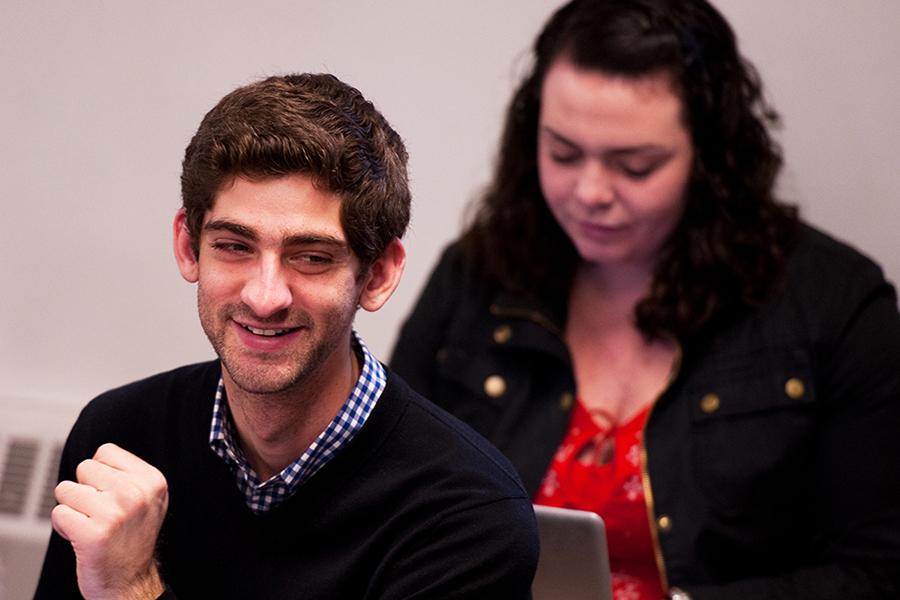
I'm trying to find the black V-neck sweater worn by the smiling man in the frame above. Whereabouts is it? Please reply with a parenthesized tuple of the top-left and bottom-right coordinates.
(35, 362, 538, 599)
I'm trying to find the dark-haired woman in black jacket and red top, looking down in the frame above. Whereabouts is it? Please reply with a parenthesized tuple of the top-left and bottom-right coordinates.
(392, 0, 900, 599)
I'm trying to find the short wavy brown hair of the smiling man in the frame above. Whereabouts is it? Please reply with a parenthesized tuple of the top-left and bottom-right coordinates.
(181, 73, 411, 269)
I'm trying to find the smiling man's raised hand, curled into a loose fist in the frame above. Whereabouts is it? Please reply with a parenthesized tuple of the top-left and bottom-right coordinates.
(51, 444, 169, 600)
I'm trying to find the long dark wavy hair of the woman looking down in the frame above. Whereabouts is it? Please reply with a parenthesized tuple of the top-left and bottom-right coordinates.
(462, 0, 797, 338)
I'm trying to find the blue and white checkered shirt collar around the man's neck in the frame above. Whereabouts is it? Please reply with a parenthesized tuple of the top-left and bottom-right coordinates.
(209, 331, 387, 513)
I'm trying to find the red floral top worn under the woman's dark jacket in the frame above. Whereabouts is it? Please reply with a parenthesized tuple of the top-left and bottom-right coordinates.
(534, 401, 663, 600)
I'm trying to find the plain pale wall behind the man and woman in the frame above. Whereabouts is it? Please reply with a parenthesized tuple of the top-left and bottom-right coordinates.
(0, 0, 900, 422)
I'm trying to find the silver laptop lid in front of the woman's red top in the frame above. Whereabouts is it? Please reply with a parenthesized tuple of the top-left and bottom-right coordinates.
(531, 505, 612, 600)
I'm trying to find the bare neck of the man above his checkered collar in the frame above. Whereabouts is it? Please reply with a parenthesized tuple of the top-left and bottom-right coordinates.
(222, 349, 361, 481)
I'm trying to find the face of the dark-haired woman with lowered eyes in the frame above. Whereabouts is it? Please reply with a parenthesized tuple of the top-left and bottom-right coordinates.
(538, 59, 693, 269)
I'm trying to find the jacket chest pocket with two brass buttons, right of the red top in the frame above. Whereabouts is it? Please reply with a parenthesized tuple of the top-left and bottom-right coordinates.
(685, 348, 816, 518)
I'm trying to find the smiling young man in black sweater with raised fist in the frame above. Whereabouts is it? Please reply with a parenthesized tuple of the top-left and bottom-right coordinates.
(36, 75, 537, 600)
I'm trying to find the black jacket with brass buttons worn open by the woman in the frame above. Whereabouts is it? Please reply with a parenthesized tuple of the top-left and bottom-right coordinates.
(391, 226, 900, 600)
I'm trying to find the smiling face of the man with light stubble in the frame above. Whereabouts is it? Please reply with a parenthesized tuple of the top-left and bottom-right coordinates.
(176, 174, 368, 394)
